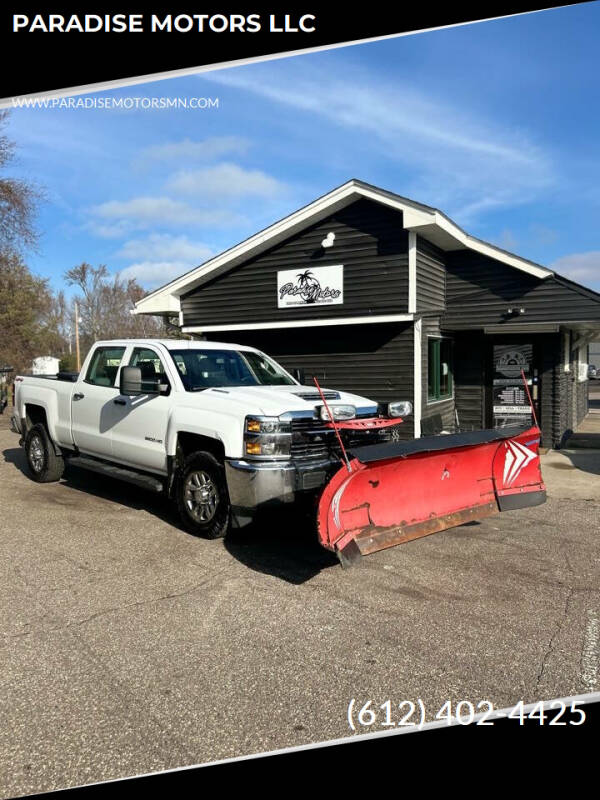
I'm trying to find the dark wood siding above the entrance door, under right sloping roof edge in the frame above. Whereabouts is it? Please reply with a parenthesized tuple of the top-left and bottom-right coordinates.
(443, 250, 600, 324)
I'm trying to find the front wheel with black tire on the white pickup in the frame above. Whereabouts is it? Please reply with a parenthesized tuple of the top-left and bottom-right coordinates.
(175, 452, 231, 539)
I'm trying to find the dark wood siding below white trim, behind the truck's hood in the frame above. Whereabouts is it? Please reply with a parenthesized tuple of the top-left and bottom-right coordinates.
(207, 324, 414, 439)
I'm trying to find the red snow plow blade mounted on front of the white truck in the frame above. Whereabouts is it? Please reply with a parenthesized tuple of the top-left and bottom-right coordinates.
(318, 427, 546, 566)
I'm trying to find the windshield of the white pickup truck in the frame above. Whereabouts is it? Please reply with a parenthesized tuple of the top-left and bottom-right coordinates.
(170, 349, 295, 392)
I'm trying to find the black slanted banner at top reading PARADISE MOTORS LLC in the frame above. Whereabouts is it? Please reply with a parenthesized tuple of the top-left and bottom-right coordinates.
(0, 2, 588, 100)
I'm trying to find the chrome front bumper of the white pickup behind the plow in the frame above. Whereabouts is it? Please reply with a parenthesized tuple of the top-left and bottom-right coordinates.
(225, 459, 339, 528)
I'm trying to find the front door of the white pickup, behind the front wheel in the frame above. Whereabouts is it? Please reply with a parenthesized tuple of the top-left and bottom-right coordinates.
(111, 347, 173, 474)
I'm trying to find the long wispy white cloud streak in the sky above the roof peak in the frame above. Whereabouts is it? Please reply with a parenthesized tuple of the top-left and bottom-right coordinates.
(201, 60, 556, 225)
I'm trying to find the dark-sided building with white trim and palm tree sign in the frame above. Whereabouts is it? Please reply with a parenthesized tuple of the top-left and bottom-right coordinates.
(136, 180, 600, 447)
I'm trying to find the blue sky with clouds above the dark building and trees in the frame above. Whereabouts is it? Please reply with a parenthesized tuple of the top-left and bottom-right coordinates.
(8, 2, 600, 296)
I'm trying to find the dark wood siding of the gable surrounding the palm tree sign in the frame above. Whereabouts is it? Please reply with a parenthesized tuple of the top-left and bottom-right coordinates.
(181, 200, 408, 326)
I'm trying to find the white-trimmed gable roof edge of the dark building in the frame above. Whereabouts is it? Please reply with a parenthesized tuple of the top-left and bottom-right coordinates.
(133, 178, 554, 314)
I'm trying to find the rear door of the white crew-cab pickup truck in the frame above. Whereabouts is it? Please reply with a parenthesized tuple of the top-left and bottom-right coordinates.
(71, 346, 125, 458)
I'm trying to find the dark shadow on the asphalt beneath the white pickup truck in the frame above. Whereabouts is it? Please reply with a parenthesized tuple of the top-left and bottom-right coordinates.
(2, 447, 339, 584)
